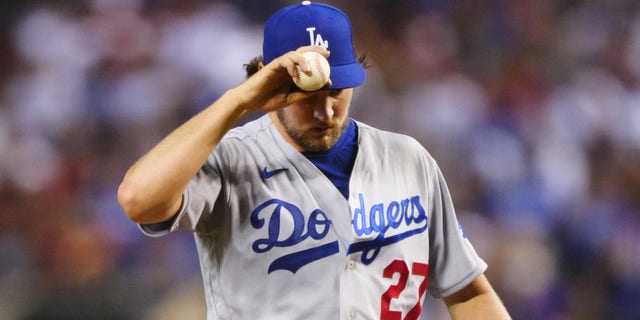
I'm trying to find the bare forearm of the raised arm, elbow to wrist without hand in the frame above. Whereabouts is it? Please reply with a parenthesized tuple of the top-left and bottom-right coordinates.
(118, 89, 247, 223)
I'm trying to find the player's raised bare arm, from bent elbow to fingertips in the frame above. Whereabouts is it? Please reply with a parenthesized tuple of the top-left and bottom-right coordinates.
(118, 46, 328, 224)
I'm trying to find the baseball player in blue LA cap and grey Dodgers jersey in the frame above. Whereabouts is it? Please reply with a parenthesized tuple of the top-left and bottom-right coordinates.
(118, 1, 509, 320)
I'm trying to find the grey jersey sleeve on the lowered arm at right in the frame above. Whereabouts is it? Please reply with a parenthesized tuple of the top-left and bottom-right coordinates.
(428, 161, 487, 298)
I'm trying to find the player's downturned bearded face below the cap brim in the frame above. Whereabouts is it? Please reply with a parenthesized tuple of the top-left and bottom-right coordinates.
(276, 89, 353, 151)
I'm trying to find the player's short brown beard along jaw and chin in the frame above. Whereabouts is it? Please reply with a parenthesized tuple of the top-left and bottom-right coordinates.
(276, 110, 348, 152)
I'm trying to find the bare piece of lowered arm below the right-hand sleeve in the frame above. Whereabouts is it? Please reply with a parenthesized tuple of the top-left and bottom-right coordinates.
(443, 275, 511, 320)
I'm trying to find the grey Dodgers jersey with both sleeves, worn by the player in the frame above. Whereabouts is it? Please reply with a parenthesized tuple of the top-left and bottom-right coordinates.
(142, 115, 487, 320)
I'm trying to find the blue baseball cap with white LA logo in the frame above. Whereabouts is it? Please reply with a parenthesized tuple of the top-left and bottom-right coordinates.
(262, 1, 366, 89)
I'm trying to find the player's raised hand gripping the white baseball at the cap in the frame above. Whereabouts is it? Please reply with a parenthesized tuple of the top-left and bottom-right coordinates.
(233, 46, 331, 112)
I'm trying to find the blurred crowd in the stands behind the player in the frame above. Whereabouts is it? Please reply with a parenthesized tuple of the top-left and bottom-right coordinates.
(0, 0, 640, 320)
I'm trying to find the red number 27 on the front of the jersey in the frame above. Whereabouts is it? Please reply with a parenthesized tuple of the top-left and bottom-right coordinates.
(380, 260, 429, 320)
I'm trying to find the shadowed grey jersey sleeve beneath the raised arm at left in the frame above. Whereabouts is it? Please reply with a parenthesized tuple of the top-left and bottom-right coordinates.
(138, 153, 222, 237)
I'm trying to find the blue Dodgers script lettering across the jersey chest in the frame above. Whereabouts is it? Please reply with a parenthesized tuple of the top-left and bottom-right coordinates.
(250, 194, 428, 273)
